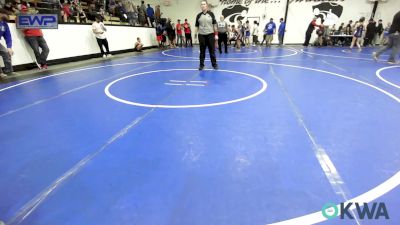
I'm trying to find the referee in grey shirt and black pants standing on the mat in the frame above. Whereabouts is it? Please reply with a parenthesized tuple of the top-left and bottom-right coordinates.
(196, 1, 218, 70)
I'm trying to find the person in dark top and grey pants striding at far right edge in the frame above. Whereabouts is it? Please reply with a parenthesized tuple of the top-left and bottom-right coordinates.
(373, 11, 400, 64)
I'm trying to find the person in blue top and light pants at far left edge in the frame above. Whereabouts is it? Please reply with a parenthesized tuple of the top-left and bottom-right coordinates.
(0, 9, 14, 78)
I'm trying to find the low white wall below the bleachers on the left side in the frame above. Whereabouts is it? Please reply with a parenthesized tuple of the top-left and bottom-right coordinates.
(0, 23, 158, 66)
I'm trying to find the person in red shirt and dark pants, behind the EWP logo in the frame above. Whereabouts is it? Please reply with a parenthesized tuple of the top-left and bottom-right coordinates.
(21, 6, 50, 69)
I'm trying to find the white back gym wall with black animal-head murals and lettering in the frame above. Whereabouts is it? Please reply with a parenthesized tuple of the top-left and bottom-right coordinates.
(159, 0, 400, 44)
